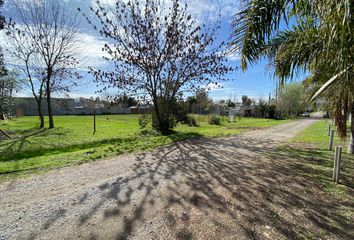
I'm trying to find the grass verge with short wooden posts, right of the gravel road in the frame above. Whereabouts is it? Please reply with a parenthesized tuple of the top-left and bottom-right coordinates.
(268, 121, 354, 232)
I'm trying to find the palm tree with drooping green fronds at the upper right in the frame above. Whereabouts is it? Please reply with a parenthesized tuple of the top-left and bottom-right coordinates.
(231, 0, 354, 153)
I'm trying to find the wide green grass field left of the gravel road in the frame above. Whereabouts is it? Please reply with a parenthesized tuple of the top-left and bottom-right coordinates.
(0, 115, 286, 176)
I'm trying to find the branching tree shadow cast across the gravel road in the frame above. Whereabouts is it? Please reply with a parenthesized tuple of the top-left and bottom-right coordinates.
(65, 137, 354, 239)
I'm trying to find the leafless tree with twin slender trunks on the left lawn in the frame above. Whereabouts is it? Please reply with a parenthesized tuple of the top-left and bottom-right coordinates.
(6, 0, 79, 128)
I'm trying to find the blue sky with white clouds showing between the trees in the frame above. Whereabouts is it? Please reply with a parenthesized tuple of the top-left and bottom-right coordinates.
(0, 0, 298, 101)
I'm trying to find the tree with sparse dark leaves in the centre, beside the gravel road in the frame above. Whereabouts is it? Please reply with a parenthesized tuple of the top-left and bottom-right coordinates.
(79, 0, 231, 132)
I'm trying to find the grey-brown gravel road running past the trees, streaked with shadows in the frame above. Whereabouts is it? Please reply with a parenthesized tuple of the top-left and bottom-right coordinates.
(0, 119, 352, 239)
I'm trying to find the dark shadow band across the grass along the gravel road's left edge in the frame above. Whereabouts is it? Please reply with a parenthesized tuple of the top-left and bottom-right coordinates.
(0, 129, 203, 175)
